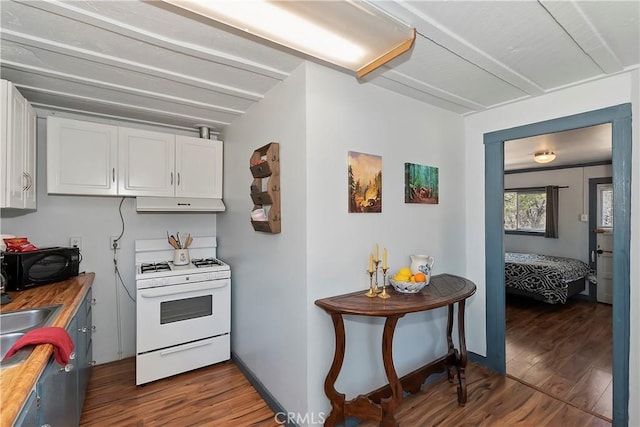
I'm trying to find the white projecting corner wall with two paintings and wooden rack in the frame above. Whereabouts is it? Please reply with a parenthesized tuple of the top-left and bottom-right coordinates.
(218, 63, 465, 420)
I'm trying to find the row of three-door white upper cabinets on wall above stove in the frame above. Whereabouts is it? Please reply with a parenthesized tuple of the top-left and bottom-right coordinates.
(47, 117, 222, 199)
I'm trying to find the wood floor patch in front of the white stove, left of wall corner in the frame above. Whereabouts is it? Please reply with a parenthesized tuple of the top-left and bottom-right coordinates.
(80, 358, 278, 427)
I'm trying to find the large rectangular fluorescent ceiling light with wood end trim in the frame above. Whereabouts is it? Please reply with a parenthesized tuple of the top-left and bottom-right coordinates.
(164, 0, 416, 77)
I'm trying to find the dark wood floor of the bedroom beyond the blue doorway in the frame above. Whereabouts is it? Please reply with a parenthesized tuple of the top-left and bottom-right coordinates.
(506, 296, 613, 419)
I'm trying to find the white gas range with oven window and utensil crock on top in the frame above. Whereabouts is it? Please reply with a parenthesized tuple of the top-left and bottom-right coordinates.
(135, 237, 231, 385)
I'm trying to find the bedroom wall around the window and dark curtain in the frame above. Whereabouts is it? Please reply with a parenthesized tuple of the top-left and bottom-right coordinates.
(504, 165, 611, 263)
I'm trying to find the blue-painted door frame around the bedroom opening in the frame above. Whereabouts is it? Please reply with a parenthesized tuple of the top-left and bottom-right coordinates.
(484, 104, 631, 427)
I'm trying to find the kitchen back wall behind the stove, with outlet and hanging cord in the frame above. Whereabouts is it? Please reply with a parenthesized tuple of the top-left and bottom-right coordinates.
(1, 115, 218, 363)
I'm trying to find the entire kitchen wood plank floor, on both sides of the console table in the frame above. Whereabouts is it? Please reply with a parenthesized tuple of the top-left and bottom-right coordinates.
(80, 358, 611, 427)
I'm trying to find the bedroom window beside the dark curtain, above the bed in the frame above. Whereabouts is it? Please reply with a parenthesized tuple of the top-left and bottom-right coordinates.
(504, 188, 547, 235)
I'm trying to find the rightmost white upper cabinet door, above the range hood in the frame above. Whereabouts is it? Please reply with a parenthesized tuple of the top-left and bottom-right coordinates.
(176, 135, 222, 198)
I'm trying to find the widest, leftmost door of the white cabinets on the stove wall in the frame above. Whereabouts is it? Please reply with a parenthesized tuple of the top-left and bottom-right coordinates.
(47, 117, 118, 196)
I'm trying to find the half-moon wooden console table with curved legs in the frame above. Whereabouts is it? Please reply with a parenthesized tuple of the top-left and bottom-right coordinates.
(315, 274, 476, 427)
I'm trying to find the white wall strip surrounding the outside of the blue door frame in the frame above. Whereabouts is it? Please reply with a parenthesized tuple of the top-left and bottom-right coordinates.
(465, 70, 640, 426)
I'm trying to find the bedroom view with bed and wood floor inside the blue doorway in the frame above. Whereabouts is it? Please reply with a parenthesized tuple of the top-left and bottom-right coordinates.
(503, 134, 613, 422)
